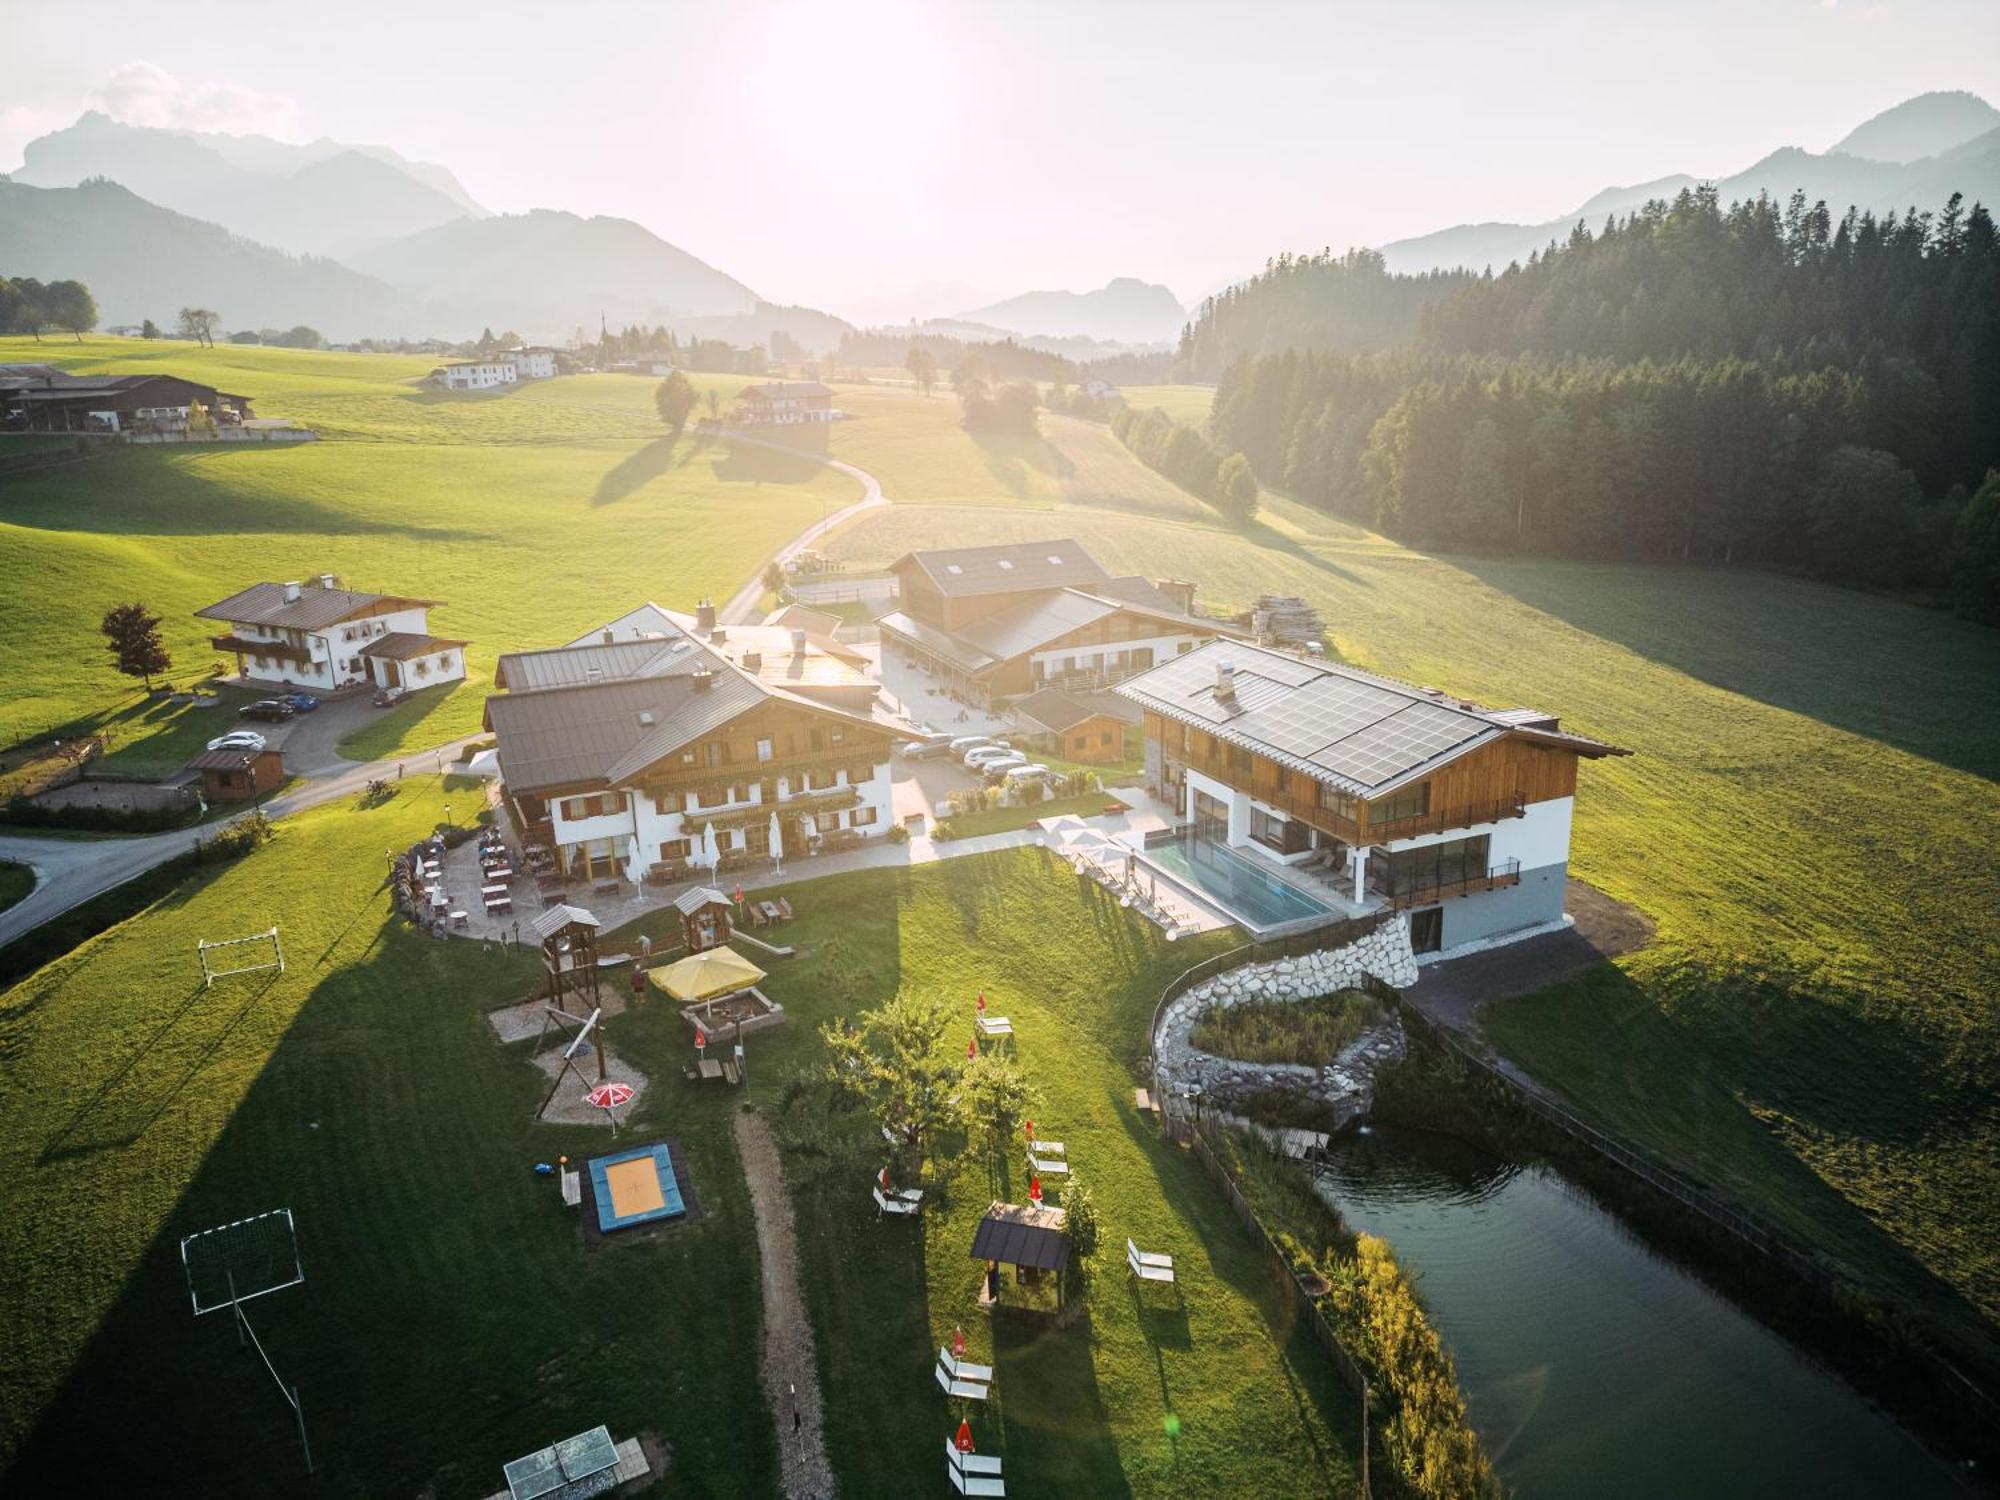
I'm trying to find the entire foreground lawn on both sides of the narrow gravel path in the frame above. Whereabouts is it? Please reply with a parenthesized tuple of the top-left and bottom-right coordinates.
(0, 804, 1352, 1500)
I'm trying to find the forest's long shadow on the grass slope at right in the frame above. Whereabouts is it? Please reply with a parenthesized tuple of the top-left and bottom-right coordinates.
(1452, 558, 2000, 780)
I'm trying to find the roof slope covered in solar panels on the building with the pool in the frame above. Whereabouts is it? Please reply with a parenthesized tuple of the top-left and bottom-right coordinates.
(1118, 642, 1510, 796)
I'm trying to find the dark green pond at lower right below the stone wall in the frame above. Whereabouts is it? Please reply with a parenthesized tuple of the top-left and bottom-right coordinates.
(1322, 1126, 1964, 1500)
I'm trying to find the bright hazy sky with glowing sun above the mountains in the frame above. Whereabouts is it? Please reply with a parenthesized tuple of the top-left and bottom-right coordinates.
(0, 0, 2000, 322)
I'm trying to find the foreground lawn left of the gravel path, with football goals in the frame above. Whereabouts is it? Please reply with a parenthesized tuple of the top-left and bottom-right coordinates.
(0, 776, 776, 1496)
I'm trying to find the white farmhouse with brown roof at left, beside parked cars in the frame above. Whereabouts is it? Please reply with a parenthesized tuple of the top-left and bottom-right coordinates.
(194, 572, 466, 692)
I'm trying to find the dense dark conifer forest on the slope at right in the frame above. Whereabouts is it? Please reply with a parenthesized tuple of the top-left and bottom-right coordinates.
(1182, 192, 2000, 596)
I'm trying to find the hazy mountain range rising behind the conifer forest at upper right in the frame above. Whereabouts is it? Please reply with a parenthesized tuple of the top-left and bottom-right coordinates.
(1382, 92, 2000, 274)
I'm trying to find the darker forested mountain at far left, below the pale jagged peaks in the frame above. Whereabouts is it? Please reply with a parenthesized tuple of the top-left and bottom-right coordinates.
(0, 178, 418, 340)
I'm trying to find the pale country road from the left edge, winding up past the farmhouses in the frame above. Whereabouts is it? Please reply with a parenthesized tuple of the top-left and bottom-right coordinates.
(0, 434, 888, 946)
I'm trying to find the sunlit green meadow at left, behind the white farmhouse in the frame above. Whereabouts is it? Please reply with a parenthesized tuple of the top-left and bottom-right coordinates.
(0, 340, 854, 770)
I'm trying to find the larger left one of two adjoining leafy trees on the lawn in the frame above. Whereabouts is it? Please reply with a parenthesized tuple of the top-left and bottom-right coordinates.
(820, 994, 964, 1164)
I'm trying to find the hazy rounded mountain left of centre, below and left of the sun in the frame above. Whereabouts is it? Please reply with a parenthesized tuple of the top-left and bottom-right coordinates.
(350, 208, 758, 340)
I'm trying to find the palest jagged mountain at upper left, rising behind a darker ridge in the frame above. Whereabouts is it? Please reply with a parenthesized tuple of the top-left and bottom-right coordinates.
(14, 112, 486, 256)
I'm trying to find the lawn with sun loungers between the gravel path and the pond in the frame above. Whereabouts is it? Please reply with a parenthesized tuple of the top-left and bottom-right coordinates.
(616, 850, 1358, 1496)
